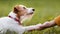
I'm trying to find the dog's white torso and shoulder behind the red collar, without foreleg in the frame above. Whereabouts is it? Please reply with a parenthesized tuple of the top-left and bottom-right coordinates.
(0, 17, 25, 33)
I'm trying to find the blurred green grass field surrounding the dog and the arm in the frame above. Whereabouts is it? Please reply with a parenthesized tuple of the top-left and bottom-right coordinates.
(0, 0, 60, 34)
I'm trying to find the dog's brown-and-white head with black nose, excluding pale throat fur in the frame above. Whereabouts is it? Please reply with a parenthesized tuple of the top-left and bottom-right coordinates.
(14, 5, 35, 16)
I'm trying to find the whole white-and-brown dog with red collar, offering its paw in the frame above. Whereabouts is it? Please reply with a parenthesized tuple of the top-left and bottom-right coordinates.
(0, 5, 41, 34)
